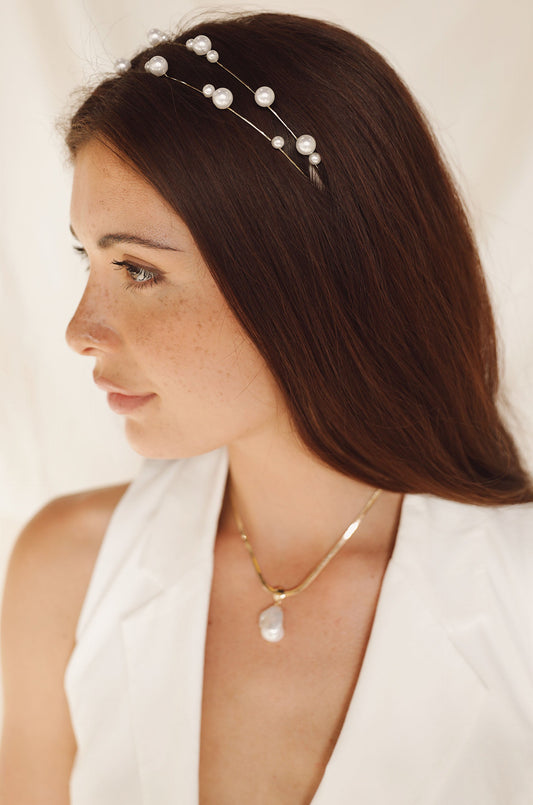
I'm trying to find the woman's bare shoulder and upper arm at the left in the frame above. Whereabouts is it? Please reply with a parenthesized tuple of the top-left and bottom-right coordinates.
(0, 484, 127, 805)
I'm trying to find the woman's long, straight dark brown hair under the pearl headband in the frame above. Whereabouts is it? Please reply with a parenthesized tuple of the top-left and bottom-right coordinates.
(67, 13, 533, 504)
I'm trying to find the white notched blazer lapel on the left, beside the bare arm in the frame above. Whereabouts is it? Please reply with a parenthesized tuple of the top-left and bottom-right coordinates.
(121, 450, 227, 805)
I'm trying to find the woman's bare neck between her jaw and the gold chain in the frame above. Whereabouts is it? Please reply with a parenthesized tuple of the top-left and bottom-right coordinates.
(220, 418, 402, 583)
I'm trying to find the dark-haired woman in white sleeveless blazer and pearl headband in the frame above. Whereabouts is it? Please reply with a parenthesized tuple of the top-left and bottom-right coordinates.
(0, 14, 533, 805)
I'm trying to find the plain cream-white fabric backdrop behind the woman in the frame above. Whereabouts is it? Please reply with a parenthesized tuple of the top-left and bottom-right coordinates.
(0, 0, 533, 716)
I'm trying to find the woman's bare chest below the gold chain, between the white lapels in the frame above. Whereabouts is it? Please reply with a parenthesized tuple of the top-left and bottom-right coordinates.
(200, 546, 387, 805)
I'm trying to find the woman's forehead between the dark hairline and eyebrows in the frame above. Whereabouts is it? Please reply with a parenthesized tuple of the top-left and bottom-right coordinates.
(70, 140, 188, 243)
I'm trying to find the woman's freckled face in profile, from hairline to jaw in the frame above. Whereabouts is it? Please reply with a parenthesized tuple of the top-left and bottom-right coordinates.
(67, 141, 285, 458)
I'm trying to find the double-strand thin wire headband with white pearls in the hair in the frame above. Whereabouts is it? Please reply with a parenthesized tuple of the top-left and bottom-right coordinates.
(115, 28, 322, 183)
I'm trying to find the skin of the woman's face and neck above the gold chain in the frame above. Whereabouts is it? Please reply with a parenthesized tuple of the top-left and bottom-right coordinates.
(67, 140, 399, 564)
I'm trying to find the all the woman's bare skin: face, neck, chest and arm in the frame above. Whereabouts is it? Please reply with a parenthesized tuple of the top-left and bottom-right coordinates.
(0, 142, 401, 805)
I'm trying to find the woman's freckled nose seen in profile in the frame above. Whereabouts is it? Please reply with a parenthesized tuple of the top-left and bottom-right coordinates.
(65, 281, 120, 355)
